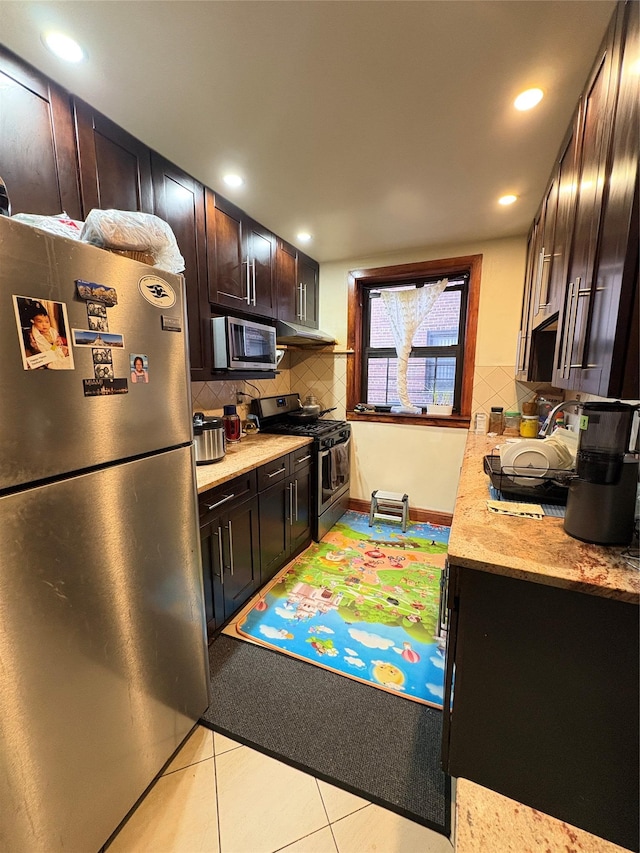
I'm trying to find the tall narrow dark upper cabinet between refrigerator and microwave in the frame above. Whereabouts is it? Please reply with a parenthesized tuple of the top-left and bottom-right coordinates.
(151, 151, 212, 382)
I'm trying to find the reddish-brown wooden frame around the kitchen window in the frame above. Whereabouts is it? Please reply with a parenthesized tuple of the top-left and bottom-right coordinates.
(347, 255, 482, 429)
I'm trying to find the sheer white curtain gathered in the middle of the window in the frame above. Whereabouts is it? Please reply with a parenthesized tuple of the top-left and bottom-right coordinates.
(380, 278, 449, 414)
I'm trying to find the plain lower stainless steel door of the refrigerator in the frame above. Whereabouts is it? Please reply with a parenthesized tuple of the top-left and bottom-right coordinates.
(0, 448, 209, 853)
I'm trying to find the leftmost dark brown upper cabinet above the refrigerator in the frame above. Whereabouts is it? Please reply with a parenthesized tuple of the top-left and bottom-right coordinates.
(0, 46, 81, 219)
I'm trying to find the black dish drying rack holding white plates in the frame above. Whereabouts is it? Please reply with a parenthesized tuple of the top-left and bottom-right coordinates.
(483, 454, 576, 505)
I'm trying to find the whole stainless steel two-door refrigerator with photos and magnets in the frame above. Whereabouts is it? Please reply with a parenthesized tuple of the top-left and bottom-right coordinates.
(0, 216, 209, 853)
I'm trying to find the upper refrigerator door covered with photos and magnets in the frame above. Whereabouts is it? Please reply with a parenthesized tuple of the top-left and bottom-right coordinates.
(0, 216, 192, 491)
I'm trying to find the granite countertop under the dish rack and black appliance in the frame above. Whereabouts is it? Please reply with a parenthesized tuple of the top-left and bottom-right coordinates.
(449, 433, 640, 604)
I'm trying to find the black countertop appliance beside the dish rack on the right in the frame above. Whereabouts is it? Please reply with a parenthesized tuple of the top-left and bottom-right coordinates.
(564, 402, 638, 545)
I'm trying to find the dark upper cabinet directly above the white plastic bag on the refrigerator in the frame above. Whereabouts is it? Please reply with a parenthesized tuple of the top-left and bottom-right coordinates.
(73, 98, 153, 218)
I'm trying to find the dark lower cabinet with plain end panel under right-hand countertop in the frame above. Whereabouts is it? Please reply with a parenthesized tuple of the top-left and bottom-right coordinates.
(443, 566, 640, 850)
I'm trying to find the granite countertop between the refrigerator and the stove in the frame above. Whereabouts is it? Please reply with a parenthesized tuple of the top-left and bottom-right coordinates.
(196, 433, 313, 494)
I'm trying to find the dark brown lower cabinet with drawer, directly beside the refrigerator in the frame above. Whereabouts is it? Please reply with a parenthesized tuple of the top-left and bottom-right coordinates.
(199, 471, 260, 638)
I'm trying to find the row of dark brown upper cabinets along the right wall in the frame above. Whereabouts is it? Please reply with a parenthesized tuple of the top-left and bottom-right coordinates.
(516, 2, 640, 399)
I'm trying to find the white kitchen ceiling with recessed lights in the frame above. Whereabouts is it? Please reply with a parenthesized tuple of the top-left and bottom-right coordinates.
(0, 0, 615, 261)
